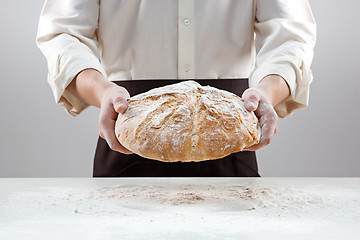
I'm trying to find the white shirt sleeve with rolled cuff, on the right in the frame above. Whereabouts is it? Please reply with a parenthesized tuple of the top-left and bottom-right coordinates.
(249, 0, 316, 117)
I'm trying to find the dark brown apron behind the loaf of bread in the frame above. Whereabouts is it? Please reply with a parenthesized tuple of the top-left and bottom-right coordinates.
(93, 79, 260, 177)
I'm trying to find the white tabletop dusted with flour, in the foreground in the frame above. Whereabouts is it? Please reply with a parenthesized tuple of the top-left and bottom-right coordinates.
(0, 178, 360, 240)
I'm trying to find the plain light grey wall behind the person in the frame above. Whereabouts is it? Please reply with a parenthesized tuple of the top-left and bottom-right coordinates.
(0, 0, 360, 177)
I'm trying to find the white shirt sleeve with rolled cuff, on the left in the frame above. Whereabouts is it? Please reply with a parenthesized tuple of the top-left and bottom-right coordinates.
(36, 0, 106, 116)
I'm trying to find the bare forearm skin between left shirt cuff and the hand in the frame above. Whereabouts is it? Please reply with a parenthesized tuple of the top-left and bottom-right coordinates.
(66, 69, 113, 107)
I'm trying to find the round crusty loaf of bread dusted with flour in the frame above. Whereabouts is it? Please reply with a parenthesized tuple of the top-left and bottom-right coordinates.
(115, 80, 260, 162)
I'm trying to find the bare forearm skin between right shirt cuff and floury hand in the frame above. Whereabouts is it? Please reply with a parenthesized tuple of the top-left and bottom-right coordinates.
(255, 75, 290, 107)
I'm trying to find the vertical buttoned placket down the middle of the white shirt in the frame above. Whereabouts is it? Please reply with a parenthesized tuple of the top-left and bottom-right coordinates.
(178, 0, 195, 79)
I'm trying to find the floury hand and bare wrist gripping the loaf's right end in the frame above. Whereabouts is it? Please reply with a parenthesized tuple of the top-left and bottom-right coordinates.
(242, 75, 290, 151)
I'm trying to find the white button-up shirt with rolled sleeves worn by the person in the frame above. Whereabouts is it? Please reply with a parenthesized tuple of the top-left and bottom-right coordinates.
(37, 0, 316, 117)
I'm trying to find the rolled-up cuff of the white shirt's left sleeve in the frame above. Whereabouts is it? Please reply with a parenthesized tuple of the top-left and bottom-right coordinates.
(48, 48, 106, 116)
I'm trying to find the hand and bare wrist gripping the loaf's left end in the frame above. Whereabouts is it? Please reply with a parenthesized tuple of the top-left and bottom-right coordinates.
(67, 69, 132, 154)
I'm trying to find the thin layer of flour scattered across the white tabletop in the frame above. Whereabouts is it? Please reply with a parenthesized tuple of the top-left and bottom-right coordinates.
(56, 185, 330, 211)
